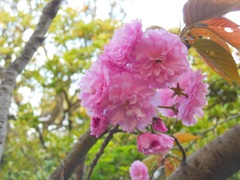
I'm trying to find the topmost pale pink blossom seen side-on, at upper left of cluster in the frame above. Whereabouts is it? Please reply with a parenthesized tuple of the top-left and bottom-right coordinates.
(99, 19, 143, 66)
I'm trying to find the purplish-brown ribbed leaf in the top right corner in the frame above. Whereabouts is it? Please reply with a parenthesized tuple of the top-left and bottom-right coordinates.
(183, 0, 240, 26)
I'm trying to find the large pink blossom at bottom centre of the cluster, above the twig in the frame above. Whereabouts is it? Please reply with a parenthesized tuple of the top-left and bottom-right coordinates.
(105, 72, 156, 132)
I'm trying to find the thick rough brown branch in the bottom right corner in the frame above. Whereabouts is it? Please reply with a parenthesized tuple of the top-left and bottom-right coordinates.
(169, 125, 240, 180)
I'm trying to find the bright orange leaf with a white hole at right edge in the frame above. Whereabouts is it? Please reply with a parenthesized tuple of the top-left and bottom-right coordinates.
(203, 18, 240, 50)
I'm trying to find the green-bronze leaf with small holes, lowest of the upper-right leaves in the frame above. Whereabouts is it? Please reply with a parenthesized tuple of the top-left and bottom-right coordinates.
(193, 39, 240, 84)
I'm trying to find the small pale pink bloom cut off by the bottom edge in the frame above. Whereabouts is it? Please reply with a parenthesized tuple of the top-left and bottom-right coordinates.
(129, 160, 149, 180)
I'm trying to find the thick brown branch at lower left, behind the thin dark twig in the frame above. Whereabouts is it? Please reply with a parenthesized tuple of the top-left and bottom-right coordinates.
(49, 130, 98, 180)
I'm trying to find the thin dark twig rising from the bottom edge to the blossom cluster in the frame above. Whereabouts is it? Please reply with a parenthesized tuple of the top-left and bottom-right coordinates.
(87, 125, 119, 180)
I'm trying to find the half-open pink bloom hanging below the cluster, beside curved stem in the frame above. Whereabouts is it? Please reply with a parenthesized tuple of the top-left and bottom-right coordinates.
(137, 132, 174, 155)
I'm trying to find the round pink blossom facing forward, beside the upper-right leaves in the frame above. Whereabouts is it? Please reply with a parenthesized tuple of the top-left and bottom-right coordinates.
(130, 29, 189, 88)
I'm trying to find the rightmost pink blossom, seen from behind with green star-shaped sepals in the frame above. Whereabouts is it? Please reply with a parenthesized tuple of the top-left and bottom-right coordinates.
(158, 69, 208, 126)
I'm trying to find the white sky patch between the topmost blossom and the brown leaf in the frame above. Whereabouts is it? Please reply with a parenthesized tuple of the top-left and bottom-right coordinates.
(126, 0, 187, 29)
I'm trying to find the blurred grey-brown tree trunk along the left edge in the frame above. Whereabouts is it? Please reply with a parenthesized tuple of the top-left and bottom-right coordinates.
(0, 0, 62, 161)
